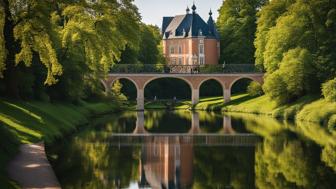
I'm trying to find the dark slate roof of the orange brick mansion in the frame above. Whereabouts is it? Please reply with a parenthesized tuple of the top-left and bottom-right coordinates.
(161, 12, 219, 39)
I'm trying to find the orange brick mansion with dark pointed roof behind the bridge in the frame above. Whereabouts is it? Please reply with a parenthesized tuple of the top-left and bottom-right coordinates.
(161, 5, 220, 65)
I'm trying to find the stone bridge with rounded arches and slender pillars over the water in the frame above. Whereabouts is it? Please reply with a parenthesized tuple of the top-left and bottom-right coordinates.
(101, 73, 264, 110)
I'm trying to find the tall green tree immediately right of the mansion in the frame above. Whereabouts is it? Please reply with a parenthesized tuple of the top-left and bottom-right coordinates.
(217, 0, 265, 64)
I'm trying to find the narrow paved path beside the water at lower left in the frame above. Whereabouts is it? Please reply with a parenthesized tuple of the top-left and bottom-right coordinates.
(9, 143, 61, 189)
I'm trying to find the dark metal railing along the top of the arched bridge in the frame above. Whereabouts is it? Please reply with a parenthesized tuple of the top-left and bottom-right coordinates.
(110, 64, 261, 74)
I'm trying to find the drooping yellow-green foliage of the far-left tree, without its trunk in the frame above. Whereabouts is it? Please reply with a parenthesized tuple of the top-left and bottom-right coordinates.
(9, 1, 62, 85)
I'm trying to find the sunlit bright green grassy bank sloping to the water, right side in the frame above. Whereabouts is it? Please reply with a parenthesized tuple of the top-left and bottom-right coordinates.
(195, 94, 336, 128)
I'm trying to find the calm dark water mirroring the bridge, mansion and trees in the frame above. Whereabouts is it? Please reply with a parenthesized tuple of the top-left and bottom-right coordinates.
(48, 111, 336, 189)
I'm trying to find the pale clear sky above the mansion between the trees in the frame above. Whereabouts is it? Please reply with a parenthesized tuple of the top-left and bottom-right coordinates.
(135, 0, 223, 27)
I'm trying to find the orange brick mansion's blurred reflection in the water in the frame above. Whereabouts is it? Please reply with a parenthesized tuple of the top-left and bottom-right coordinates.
(139, 137, 193, 188)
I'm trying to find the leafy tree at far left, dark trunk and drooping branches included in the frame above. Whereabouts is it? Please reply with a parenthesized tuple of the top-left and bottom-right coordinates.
(0, 0, 62, 97)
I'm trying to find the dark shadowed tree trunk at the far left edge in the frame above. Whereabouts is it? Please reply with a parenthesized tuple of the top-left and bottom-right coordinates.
(2, 0, 19, 98)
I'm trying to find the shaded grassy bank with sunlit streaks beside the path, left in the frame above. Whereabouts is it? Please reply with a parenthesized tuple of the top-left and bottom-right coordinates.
(0, 99, 120, 188)
